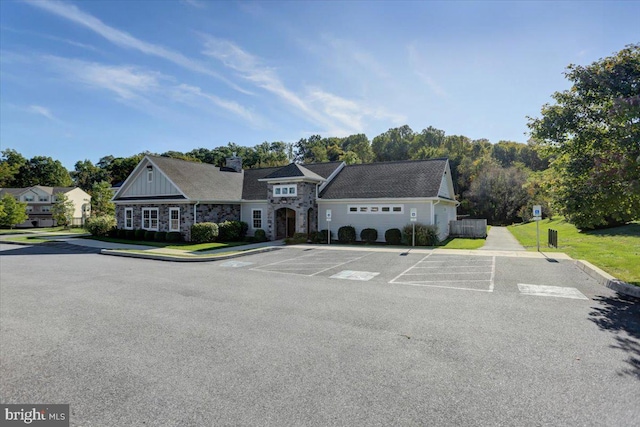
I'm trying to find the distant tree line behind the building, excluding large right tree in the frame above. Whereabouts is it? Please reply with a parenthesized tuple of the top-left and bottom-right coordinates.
(0, 131, 548, 226)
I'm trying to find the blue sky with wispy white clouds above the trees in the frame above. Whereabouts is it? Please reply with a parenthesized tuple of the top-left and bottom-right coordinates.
(0, 0, 640, 169)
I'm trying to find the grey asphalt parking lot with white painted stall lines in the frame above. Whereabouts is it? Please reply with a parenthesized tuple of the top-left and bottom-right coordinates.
(0, 244, 640, 426)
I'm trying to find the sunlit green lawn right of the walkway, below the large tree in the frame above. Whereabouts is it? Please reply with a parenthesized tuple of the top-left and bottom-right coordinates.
(509, 218, 640, 286)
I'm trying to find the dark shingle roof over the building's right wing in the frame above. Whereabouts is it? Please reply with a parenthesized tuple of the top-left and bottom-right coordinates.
(320, 159, 447, 199)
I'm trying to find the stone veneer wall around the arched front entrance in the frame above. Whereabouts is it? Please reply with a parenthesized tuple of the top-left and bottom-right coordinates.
(265, 182, 318, 240)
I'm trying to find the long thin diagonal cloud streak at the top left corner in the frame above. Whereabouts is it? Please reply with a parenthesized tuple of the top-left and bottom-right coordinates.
(25, 0, 250, 94)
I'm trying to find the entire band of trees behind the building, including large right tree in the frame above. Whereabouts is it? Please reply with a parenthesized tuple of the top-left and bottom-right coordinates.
(0, 45, 640, 229)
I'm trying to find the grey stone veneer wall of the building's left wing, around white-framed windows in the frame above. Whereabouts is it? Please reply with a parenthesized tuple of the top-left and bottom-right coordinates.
(116, 203, 240, 241)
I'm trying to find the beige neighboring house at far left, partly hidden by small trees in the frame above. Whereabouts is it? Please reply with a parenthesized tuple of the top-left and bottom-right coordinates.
(0, 185, 91, 227)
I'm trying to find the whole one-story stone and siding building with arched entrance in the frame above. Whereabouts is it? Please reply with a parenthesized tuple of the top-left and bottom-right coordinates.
(113, 156, 458, 241)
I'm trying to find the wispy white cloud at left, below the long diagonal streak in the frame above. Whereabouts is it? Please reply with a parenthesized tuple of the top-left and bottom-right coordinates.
(45, 56, 263, 127)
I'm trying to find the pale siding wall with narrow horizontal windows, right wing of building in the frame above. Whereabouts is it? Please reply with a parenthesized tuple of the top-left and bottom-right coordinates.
(318, 200, 431, 242)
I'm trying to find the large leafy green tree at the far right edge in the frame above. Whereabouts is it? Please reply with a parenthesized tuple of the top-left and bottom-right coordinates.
(529, 44, 640, 229)
